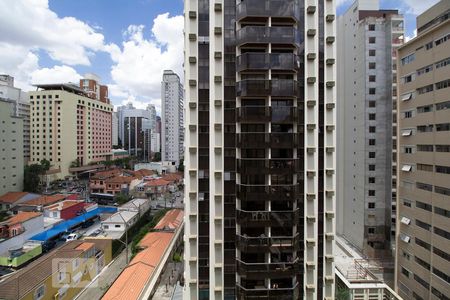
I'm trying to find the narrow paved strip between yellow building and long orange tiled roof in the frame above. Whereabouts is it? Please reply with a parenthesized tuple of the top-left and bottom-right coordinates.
(75, 250, 131, 300)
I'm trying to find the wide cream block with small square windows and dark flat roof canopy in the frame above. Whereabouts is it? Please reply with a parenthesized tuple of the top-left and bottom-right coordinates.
(29, 79, 113, 180)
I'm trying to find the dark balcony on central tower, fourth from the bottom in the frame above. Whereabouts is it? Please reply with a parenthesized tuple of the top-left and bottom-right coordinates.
(236, 208, 300, 227)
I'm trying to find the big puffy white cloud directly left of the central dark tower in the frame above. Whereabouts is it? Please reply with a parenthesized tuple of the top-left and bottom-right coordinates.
(108, 13, 184, 107)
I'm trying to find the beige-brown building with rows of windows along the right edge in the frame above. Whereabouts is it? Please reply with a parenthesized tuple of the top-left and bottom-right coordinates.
(396, 1, 450, 299)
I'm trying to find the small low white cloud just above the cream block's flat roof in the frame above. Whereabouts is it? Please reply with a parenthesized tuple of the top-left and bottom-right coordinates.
(31, 66, 82, 84)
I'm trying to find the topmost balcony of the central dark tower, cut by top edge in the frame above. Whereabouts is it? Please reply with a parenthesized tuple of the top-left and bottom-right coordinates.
(236, 0, 300, 21)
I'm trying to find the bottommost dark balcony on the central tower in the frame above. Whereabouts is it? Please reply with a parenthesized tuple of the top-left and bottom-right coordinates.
(236, 283, 299, 300)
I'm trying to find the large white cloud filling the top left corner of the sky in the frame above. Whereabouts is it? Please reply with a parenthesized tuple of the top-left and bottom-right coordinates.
(0, 0, 108, 65)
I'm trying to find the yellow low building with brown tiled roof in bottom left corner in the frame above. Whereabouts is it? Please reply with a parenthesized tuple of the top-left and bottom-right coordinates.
(0, 238, 112, 300)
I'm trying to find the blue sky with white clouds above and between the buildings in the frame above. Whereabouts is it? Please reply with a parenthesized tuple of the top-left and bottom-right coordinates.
(0, 0, 437, 110)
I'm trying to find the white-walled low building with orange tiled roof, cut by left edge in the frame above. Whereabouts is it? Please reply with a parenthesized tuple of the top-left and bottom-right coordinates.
(0, 212, 44, 253)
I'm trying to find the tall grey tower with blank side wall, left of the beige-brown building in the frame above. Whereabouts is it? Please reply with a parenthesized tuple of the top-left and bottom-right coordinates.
(336, 0, 404, 257)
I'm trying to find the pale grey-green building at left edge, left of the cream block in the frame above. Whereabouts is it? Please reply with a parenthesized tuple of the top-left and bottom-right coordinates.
(0, 98, 24, 195)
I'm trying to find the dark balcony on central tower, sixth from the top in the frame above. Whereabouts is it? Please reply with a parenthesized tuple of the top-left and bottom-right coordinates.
(236, 132, 299, 149)
